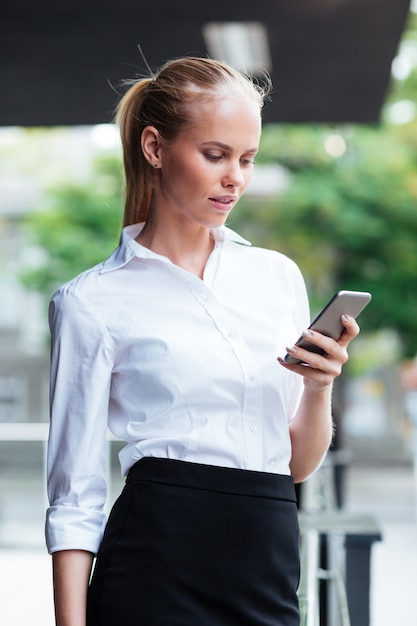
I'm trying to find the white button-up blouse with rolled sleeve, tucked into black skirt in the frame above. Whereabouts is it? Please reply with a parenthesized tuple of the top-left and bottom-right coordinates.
(46, 225, 309, 553)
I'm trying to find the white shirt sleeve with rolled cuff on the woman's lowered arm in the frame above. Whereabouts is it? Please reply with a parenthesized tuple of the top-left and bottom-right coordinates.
(46, 286, 113, 553)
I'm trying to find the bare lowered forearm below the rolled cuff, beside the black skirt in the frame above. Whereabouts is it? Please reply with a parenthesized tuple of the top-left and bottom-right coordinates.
(52, 550, 93, 626)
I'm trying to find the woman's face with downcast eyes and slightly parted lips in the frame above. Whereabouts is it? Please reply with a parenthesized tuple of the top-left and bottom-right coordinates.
(150, 95, 261, 228)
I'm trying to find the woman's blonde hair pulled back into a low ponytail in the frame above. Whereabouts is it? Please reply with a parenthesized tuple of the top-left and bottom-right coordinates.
(116, 57, 270, 226)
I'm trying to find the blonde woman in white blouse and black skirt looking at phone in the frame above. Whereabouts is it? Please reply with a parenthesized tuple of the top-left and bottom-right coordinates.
(47, 58, 358, 626)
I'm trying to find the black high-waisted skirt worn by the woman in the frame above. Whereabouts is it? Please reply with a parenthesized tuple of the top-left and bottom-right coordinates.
(87, 458, 299, 626)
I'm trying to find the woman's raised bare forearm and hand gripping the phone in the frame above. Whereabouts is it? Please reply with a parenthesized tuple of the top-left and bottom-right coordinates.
(279, 316, 359, 483)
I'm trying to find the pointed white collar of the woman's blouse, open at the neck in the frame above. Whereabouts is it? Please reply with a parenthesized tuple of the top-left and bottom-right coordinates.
(100, 222, 252, 273)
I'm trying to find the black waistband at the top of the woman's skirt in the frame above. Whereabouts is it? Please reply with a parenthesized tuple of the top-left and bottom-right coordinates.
(126, 457, 296, 502)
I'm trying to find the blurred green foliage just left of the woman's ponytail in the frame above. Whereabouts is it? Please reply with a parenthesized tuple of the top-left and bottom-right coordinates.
(22, 158, 121, 297)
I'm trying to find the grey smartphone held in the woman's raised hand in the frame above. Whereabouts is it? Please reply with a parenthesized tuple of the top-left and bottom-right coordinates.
(284, 291, 372, 363)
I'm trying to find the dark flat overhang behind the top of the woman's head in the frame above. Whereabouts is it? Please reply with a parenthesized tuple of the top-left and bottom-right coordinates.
(0, 0, 409, 126)
